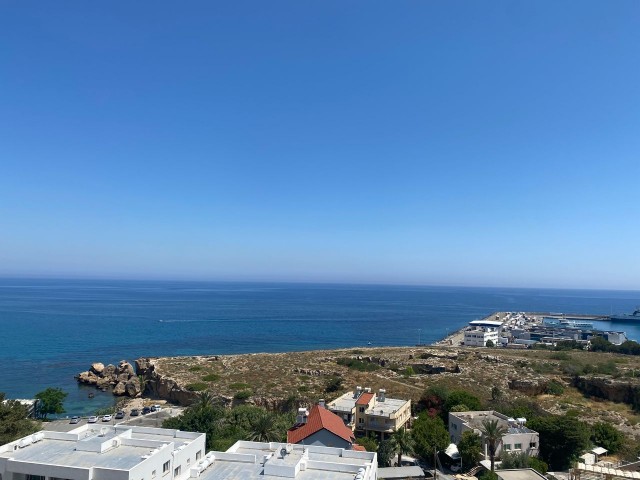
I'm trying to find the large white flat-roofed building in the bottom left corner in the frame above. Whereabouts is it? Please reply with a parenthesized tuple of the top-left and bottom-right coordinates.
(0, 424, 205, 480)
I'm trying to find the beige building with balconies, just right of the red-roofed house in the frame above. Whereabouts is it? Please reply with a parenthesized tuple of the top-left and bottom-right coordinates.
(327, 387, 411, 439)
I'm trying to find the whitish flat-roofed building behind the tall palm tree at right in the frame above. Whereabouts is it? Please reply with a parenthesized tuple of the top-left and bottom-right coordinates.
(449, 410, 540, 457)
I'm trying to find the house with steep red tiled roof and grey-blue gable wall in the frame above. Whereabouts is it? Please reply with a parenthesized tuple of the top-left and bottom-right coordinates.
(287, 405, 355, 450)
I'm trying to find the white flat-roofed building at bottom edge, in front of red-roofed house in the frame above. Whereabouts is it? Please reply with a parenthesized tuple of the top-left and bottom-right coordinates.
(192, 441, 378, 480)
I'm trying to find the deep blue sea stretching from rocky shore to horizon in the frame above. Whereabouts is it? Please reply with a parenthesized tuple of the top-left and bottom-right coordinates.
(0, 278, 640, 416)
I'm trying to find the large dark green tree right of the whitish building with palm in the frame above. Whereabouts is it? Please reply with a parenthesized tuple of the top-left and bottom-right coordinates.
(527, 414, 591, 470)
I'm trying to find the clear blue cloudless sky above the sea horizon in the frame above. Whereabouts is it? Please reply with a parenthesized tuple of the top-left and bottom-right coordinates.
(0, 0, 640, 289)
